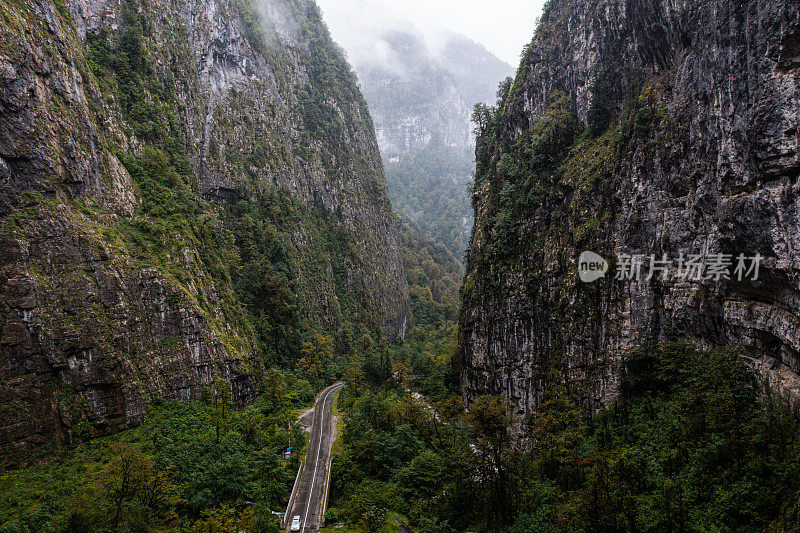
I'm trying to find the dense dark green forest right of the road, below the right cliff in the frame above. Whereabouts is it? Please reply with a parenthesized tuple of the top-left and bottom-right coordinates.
(328, 342, 800, 533)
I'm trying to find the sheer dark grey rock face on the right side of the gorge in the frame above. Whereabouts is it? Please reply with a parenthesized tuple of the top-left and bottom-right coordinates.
(460, 0, 800, 414)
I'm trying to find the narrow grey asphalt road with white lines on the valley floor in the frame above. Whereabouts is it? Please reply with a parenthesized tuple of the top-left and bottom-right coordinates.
(287, 383, 344, 533)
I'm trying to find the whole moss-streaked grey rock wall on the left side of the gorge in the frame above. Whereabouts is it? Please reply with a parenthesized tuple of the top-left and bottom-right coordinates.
(0, 0, 409, 462)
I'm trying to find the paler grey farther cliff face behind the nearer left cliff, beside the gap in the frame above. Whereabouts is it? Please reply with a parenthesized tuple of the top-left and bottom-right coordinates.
(70, 0, 408, 335)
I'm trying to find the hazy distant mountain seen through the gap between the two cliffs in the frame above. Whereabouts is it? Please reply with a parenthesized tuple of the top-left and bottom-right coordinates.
(325, 7, 513, 257)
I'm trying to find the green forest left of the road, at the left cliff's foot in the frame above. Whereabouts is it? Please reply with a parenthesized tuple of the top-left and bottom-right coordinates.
(0, 376, 314, 533)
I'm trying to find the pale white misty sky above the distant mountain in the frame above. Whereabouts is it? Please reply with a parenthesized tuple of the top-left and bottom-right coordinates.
(317, 0, 545, 67)
